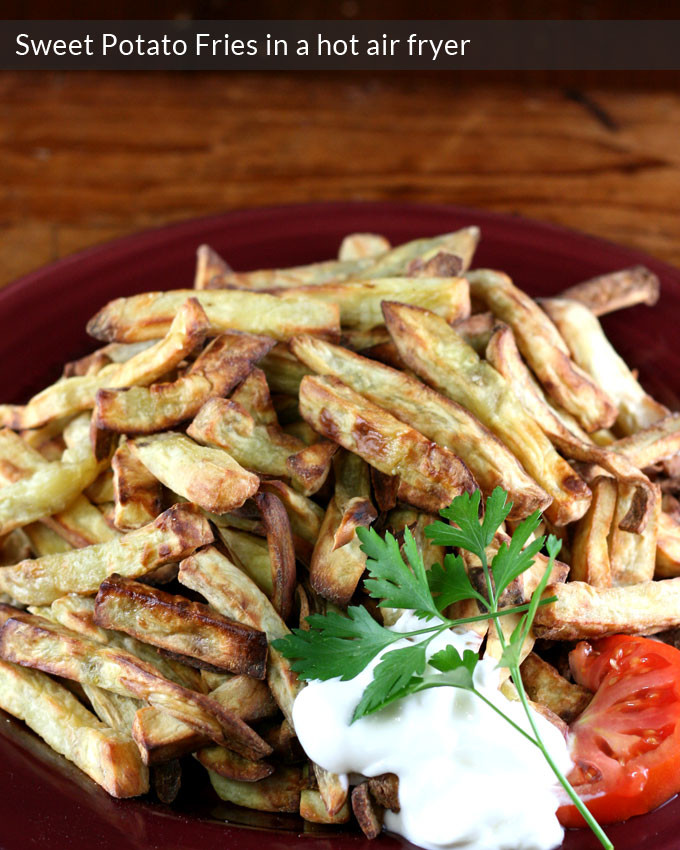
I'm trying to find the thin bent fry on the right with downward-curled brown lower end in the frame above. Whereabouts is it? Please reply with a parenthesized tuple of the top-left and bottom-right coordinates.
(486, 325, 656, 534)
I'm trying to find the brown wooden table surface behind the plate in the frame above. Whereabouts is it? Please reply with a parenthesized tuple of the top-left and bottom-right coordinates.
(0, 72, 680, 285)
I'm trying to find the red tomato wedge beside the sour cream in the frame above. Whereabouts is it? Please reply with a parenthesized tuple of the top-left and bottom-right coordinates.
(557, 635, 680, 826)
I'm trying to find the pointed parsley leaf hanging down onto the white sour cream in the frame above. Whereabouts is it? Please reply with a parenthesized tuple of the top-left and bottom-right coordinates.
(352, 640, 428, 722)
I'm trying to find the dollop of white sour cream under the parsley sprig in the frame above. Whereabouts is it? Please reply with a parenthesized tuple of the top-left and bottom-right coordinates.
(293, 612, 572, 850)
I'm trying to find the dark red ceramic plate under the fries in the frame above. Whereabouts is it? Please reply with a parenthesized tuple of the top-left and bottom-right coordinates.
(0, 203, 680, 850)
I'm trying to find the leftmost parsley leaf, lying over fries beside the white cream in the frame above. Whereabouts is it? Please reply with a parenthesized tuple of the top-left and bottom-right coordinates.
(272, 606, 402, 681)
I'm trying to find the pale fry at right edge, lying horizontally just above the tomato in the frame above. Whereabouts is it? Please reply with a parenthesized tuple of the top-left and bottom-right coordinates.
(533, 578, 680, 640)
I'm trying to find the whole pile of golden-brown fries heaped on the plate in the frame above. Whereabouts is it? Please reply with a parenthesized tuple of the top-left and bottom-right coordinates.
(0, 227, 680, 836)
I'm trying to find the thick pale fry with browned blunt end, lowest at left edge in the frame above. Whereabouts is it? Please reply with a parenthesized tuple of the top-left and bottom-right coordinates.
(0, 661, 149, 797)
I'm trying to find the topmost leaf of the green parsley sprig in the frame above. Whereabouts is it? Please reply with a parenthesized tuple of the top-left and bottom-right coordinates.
(425, 480, 512, 560)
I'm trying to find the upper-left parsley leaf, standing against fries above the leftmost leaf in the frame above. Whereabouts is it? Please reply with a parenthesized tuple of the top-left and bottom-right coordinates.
(356, 527, 439, 619)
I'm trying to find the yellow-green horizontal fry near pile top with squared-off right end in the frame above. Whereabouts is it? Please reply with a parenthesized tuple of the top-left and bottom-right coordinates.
(271, 277, 470, 330)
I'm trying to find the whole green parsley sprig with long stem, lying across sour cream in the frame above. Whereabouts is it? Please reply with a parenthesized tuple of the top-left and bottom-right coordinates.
(272, 487, 613, 850)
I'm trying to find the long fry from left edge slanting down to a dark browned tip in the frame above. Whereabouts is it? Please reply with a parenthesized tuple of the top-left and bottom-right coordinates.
(0, 617, 271, 758)
